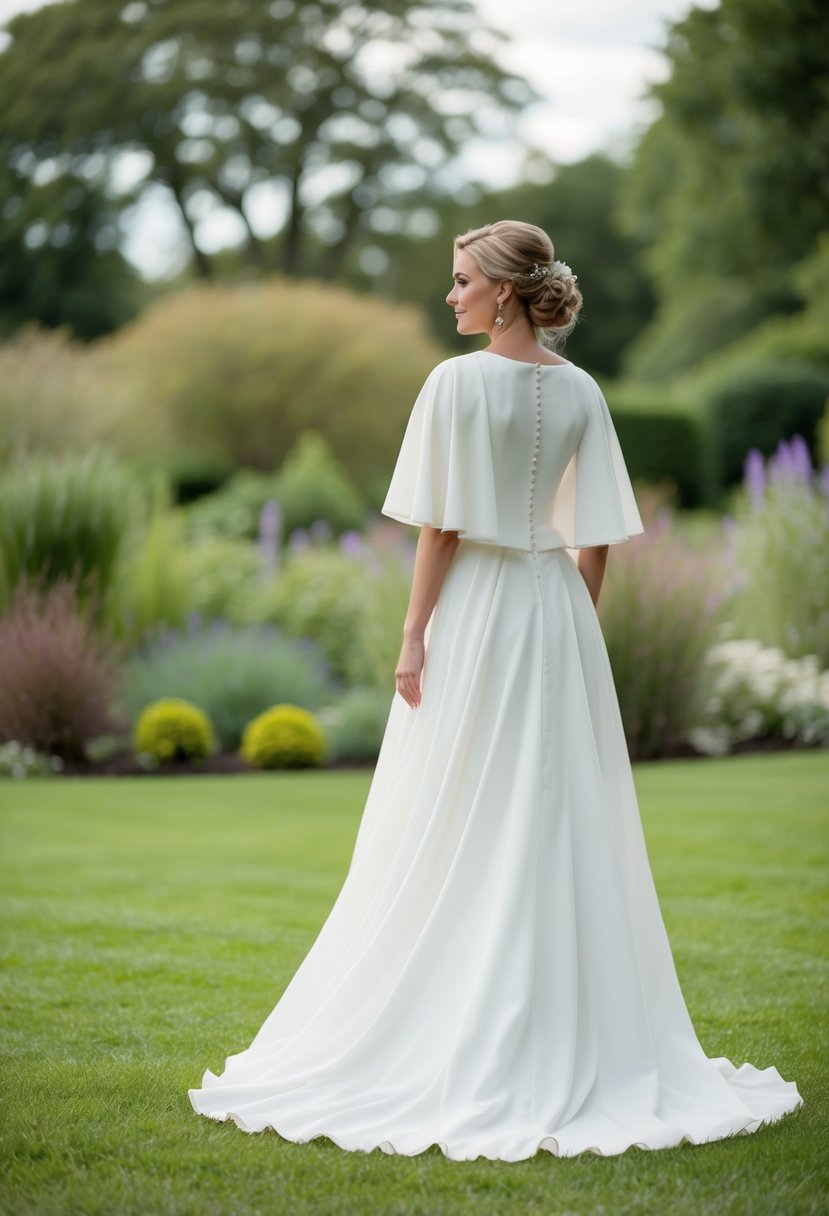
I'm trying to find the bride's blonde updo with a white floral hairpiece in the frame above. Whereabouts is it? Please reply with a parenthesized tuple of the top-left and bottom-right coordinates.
(455, 220, 581, 345)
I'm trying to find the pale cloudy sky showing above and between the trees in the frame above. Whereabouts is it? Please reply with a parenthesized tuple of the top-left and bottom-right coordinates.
(0, 0, 716, 276)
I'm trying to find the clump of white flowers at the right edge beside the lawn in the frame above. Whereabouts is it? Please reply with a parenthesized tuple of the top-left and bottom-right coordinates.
(689, 638, 829, 755)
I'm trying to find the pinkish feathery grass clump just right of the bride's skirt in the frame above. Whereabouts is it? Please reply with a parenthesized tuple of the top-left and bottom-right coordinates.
(599, 495, 723, 760)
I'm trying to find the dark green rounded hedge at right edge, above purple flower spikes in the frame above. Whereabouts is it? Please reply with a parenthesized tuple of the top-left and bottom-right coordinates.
(706, 361, 829, 486)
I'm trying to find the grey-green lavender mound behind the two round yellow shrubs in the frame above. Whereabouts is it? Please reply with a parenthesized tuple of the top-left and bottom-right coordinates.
(120, 623, 332, 751)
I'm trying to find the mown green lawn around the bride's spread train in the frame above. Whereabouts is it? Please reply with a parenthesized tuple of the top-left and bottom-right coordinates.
(0, 751, 829, 1216)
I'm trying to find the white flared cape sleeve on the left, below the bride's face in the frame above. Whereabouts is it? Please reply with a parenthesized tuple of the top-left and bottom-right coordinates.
(380, 359, 498, 541)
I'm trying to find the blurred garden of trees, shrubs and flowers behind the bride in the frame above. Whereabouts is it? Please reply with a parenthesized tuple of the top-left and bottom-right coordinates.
(0, 0, 829, 776)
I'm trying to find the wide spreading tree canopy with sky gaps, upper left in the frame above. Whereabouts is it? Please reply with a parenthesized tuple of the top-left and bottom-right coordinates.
(0, 0, 532, 294)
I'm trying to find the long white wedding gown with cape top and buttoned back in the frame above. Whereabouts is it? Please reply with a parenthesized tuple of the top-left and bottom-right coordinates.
(190, 351, 802, 1161)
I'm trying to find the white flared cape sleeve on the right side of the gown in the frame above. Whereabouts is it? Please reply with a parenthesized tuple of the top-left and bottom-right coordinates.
(551, 378, 644, 548)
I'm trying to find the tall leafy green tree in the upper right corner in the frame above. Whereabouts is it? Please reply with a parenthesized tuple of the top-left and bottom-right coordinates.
(625, 0, 829, 375)
